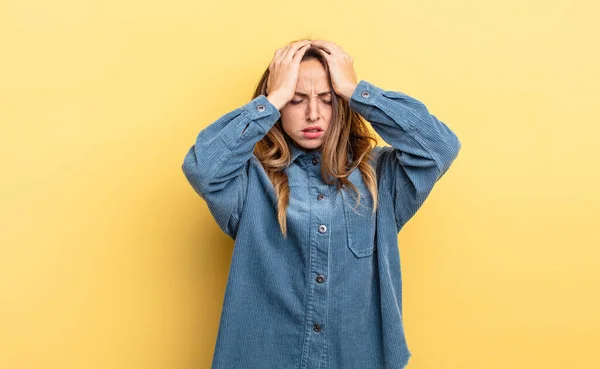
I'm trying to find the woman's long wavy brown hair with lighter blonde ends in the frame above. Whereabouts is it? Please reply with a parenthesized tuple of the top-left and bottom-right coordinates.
(252, 42, 377, 237)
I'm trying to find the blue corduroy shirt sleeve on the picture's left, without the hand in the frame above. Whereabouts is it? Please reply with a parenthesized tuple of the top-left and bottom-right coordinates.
(182, 95, 280, 239)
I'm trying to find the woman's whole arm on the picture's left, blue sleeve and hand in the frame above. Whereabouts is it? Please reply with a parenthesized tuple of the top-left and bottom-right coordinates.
(182, 40, 310, 239)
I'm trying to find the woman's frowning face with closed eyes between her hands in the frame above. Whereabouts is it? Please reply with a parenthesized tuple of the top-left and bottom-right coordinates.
(281, 59, 333, 150)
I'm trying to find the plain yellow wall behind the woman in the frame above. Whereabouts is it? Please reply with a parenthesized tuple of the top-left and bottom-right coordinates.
(0, 0, 600, 369)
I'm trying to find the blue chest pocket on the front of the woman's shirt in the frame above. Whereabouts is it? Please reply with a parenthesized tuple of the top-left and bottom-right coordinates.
(343, 182, 376, 258)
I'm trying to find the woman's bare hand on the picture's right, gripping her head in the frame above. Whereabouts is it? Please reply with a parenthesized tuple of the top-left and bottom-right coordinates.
(310, 40, 358, 100)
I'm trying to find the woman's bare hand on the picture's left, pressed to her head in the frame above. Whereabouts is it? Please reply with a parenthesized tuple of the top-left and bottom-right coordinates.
(267, 40, 310, 110)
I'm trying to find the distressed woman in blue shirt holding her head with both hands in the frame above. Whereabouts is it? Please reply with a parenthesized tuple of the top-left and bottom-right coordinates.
(183, 40, 461, 369)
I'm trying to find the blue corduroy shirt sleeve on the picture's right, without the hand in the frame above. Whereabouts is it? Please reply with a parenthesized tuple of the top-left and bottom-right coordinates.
(349, 80, 461, 232)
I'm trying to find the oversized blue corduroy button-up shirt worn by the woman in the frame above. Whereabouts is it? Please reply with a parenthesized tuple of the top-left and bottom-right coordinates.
(182, 80, 461, 369)
